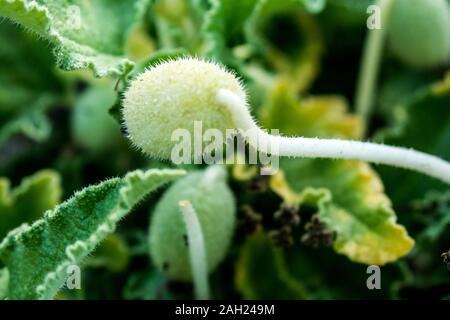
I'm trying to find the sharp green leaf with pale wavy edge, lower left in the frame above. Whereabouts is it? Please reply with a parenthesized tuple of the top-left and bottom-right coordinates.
(0, 169, 184, 299)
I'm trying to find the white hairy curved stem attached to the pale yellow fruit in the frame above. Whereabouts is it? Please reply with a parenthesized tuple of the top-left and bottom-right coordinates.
(217, 89, 450, 184)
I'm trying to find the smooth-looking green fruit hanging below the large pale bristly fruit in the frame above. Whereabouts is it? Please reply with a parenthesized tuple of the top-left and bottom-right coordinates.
(149, 166, 236, 281)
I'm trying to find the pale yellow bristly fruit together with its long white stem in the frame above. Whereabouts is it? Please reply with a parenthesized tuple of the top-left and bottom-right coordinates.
(123, 58, 450, 184)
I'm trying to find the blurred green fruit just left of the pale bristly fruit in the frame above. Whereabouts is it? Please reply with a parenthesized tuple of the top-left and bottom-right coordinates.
(72, 86, 122, 151)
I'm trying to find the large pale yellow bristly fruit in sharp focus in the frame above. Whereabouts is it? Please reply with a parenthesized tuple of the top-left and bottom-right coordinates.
(123, 58, 246, 159)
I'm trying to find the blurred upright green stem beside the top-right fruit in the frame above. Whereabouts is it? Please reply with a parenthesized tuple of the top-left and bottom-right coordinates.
(355, 0, 395, 134)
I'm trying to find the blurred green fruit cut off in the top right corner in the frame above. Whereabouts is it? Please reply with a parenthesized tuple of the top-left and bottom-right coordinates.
(388, 0, 450, 68)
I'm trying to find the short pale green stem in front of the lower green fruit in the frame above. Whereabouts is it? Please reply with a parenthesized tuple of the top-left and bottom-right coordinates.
(179, 200, 209, 300)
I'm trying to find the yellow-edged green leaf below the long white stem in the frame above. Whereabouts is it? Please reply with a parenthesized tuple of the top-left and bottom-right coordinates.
(272, 159, 414, 265)
